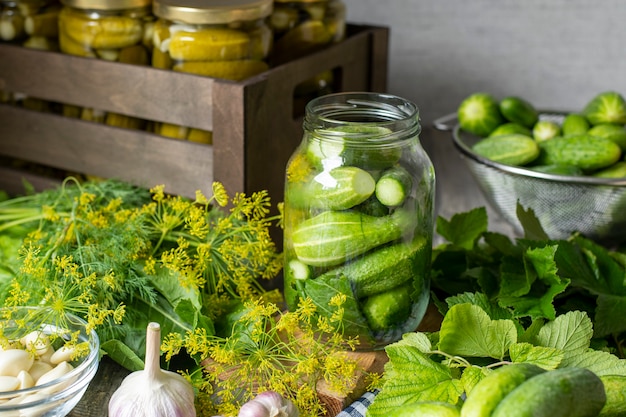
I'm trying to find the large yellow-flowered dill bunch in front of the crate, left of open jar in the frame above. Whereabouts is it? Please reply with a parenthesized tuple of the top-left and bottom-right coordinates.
(0, 179, 282, 348)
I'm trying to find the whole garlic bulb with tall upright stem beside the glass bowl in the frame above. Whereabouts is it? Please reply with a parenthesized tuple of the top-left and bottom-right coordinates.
(109, 323, 196, 417)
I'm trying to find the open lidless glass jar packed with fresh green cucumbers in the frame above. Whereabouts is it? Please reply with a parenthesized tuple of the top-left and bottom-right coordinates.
(284, 92, 435, 350)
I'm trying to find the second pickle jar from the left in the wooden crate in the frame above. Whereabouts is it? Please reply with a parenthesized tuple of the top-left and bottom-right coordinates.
(59, 0, 154, 129)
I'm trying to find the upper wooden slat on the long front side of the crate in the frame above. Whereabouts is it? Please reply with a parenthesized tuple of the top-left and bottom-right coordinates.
(0, 44, 214, 130)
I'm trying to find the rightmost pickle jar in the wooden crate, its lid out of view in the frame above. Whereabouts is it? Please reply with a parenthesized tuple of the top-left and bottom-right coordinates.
(270, 0, 346, 65)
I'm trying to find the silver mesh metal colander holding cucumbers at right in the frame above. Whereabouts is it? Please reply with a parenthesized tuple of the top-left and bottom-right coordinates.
(434, 112, 626, 243)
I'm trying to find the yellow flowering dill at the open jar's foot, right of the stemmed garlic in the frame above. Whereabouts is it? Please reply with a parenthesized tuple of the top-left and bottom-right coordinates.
(162, 299, 358, 417)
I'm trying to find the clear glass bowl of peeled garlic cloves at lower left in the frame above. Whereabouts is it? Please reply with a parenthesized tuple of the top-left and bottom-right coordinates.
(0, 307, 100, 417)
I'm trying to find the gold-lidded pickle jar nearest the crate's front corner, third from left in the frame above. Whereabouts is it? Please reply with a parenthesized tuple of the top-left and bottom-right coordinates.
(152, 0, 273, 143)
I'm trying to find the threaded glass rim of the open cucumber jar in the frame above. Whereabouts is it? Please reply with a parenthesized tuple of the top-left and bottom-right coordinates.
(303, 92, 421, 144)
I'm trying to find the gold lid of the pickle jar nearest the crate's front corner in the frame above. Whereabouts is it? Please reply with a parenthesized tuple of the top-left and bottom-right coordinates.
(153, 0, 274, 24)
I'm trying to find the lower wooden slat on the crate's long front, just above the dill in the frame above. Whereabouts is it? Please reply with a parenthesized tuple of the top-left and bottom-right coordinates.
(0, 105, 213, 196)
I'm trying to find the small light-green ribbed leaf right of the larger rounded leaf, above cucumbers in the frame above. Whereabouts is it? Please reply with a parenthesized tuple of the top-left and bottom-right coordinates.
(534, 311, 593, 356)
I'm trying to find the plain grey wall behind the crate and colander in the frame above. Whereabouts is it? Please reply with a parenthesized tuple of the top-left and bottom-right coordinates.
(344, 0, 626, 239)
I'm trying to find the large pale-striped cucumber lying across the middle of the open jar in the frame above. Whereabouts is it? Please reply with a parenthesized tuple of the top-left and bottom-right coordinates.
(291, 209, 417, 266)
